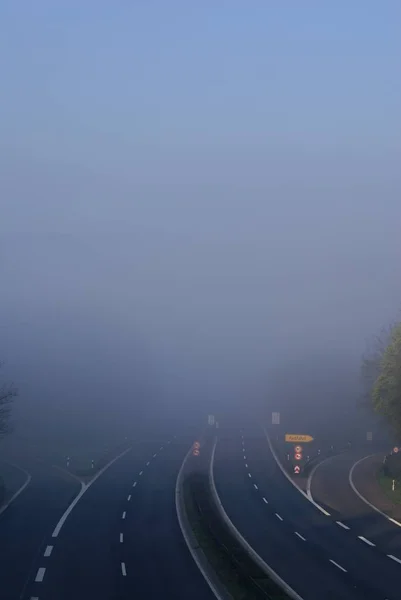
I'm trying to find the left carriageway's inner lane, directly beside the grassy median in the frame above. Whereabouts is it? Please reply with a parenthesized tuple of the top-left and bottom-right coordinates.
(120, 438, 215, 600)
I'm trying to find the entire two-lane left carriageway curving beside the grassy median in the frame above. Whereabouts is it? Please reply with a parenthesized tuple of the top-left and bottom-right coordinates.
(24, 439, 214, 600)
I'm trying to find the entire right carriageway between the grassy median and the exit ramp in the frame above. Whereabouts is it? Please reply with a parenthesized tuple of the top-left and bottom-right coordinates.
(215, 427, 401, 600)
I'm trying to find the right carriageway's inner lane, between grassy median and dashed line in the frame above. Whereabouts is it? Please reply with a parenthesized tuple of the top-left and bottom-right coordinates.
(214, 430, 368, 600)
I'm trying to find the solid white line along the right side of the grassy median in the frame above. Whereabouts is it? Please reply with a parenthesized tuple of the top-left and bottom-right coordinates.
(209, 438, 303, 600)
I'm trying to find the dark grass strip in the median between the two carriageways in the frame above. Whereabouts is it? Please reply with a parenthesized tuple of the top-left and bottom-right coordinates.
(183, 473, 289, 600)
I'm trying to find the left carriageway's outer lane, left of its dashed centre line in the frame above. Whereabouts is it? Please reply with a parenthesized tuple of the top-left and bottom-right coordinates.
(24, 442, 157, 600)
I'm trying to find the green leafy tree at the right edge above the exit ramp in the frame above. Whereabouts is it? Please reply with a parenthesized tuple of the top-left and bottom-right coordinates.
(371, 322, 401, 439)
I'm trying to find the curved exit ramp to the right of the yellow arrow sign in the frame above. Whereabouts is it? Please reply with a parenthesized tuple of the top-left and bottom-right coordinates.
(310, 450, 401, 568)
